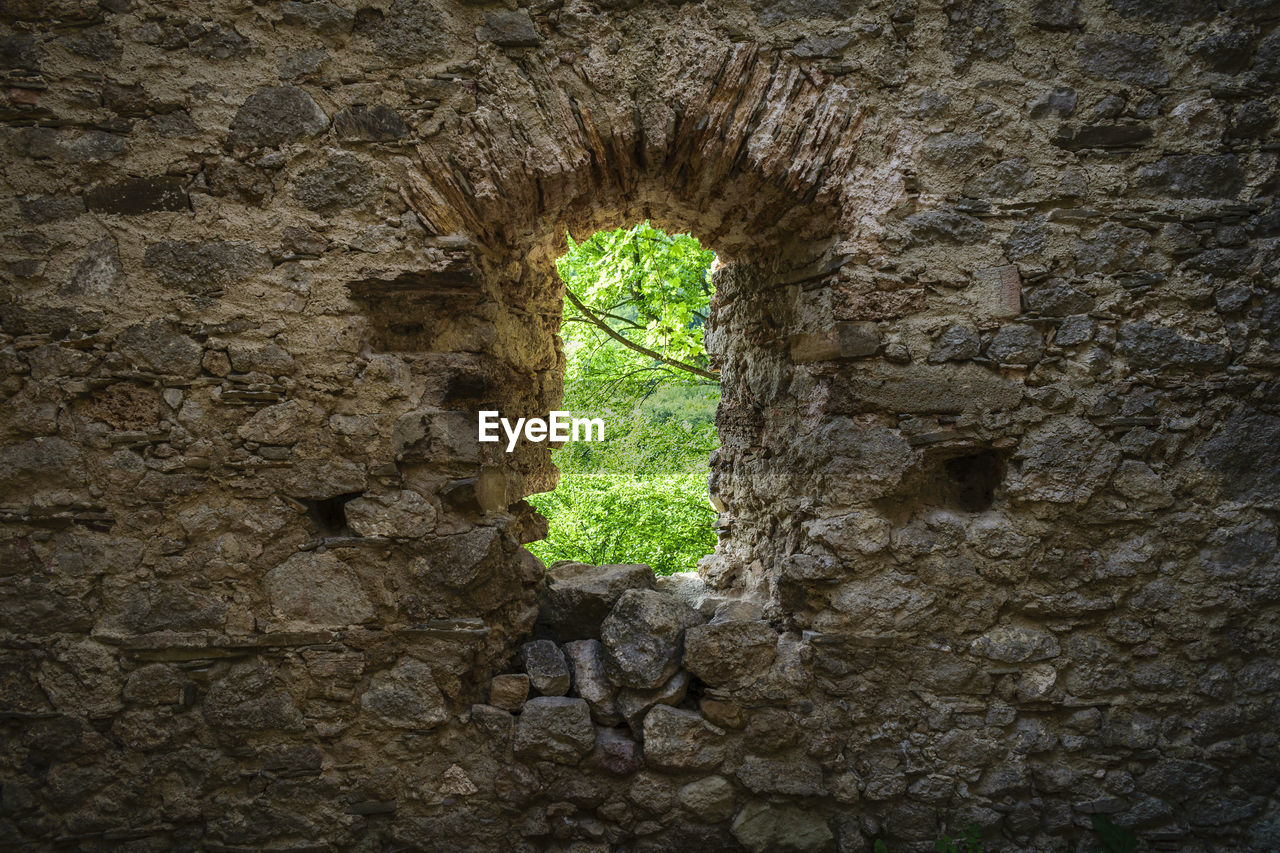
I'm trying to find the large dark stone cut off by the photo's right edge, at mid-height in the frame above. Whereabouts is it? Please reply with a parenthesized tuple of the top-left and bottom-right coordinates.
(1197, 409, 1280, 502)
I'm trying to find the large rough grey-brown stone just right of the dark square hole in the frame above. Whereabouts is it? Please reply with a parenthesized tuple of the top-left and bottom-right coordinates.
(1005, 416, 1120, 503)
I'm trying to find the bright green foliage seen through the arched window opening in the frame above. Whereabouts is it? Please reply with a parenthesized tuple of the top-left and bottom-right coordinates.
(529, 223, 719, 574)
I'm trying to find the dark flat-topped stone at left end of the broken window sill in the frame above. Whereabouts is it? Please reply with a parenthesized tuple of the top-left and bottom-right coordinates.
(538, 561, 654, 642)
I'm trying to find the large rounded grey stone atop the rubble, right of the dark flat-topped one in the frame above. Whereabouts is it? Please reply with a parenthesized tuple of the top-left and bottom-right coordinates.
(600, 589, 703, 690)
